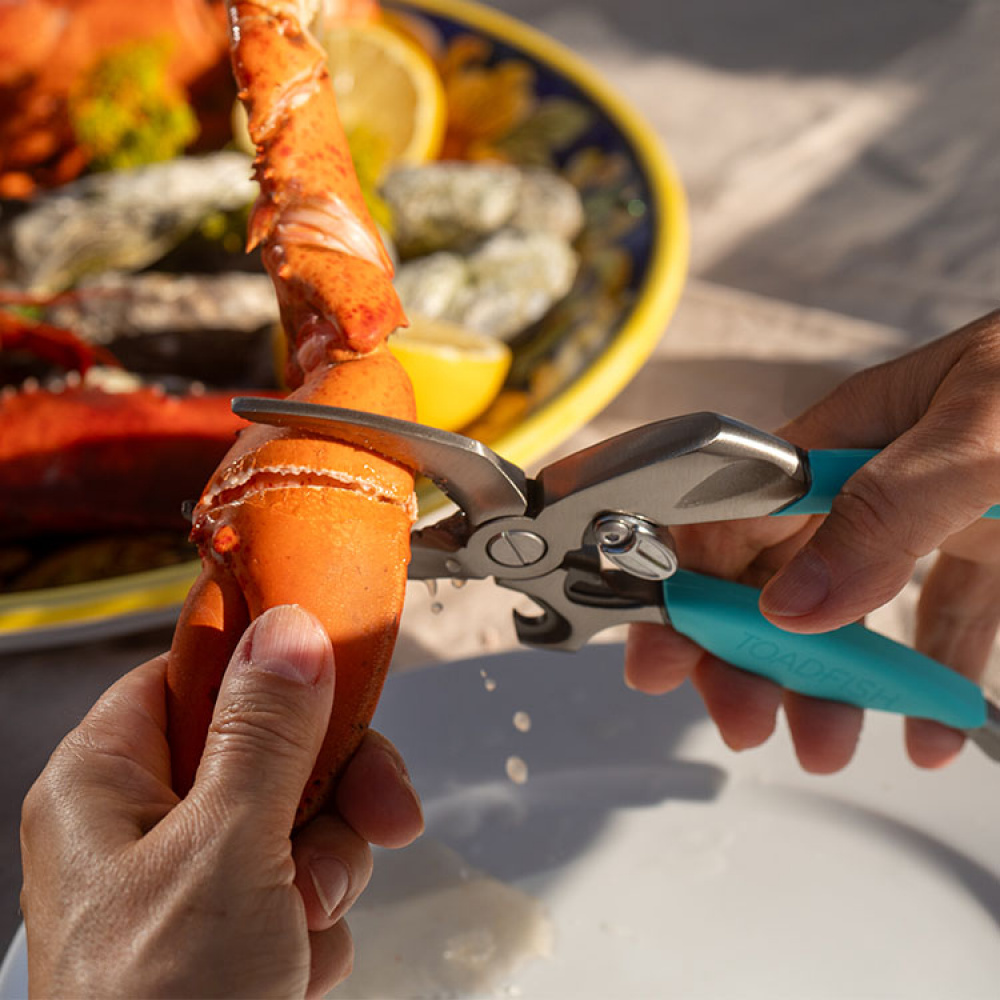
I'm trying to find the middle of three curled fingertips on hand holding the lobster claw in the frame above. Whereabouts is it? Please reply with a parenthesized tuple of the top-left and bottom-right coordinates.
(292, 815, 372, 931)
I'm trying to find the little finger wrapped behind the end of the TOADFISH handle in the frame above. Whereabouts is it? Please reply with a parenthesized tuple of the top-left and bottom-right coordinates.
(906, 554, 1000, 768)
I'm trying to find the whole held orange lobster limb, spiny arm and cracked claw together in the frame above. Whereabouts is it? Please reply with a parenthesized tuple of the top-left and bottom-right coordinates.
(168, 0, 415, 823)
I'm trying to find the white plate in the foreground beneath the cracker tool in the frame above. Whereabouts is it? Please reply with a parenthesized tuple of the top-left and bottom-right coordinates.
(0, 645, 1000, 1000)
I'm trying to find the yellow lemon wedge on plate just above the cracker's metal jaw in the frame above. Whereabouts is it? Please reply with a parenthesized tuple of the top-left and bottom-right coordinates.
(388, 316, 511, 431)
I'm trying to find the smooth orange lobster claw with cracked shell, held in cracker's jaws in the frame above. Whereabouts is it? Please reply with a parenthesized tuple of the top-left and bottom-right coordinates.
(167, 347, 415, 822)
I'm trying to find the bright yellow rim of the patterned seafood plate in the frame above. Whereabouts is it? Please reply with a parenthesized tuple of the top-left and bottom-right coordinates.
(0, 0, 690, 651)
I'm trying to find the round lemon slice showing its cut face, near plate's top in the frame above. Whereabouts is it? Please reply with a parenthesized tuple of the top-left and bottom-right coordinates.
(320, 21, 447, 164)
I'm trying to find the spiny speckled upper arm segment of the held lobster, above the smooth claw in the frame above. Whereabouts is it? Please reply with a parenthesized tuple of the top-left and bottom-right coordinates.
(229, 0, 406, 376)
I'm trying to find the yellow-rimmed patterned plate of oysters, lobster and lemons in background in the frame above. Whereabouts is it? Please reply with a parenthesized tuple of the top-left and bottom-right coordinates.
(0, 0, 687, 651)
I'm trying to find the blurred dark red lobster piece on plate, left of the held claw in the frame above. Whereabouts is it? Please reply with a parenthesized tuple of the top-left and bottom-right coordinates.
(0, 383, 254, 541)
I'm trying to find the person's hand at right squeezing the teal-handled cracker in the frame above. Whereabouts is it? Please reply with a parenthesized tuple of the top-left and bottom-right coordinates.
(625, 312, 1000, 773)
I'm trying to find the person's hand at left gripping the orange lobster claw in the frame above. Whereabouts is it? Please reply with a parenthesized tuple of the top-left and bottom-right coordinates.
(21, 606, 423, 997)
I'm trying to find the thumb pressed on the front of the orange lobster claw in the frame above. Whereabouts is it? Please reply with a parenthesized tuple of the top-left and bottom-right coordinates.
(189, 605, 334, 837)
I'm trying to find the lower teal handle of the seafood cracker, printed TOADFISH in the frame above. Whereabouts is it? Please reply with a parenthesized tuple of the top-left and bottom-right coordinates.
(663, 570, 987, 729)
